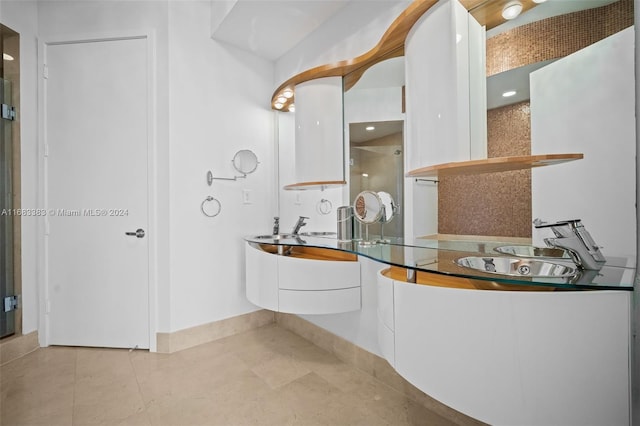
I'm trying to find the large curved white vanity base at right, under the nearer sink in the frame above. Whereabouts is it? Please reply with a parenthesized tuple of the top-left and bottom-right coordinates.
(378, 271, 631, 425)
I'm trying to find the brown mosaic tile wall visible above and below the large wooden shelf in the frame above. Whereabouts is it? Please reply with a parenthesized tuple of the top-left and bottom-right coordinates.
(438, 0, 633, 237)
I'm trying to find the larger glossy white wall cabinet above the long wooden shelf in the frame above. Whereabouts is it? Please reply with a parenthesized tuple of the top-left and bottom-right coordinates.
(405, 0, 486, 170)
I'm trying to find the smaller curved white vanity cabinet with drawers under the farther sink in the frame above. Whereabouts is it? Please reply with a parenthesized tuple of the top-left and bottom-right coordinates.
(246, 244, 361, 314)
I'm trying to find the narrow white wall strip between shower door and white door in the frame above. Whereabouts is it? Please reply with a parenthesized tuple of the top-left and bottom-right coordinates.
(0, 0, 41, 334)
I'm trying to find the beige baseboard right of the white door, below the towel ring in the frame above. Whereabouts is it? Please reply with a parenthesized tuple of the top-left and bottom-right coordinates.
(156, 309, 275, 353)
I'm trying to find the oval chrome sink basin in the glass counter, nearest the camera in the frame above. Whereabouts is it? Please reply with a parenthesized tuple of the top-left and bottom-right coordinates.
(455, 256, 576, 278)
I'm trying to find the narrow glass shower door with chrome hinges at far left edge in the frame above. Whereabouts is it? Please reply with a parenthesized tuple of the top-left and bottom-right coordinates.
(0, 79, 15, 338)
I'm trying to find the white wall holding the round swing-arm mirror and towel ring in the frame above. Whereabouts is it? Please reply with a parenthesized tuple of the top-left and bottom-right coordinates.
(169, 1, 275, 331)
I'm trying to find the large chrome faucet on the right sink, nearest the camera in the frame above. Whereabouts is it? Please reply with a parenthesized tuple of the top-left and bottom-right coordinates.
(534, 219, 607, 271)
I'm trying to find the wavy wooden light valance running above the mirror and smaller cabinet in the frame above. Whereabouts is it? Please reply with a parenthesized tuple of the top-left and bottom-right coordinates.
(271, 0, 438, 110)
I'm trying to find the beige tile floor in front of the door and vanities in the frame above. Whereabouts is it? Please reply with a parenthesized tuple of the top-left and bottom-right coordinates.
(0, 324, 460, 426)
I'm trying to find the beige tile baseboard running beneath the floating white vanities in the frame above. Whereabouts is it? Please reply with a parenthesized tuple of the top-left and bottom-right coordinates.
(275, 312, 484, 426)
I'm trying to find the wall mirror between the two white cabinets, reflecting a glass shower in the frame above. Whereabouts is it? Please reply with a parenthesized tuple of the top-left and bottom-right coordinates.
(344, 57, 405, 238)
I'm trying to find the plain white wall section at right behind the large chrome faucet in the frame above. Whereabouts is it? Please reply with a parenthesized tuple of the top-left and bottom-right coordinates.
(531, 27, 636, 257)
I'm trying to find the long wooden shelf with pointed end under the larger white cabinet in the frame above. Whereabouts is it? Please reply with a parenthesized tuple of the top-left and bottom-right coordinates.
(406, 154, 583, 177)
